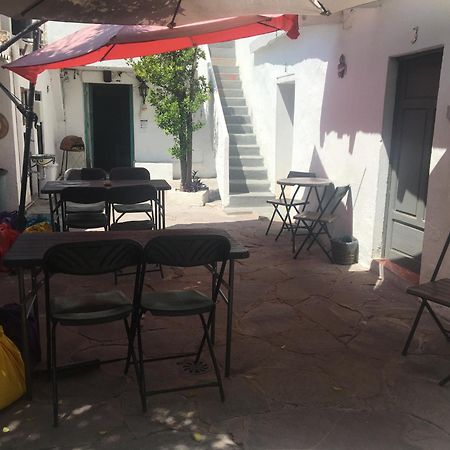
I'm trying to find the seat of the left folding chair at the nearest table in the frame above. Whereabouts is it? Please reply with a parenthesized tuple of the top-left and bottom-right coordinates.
(50, 290, 132, 325)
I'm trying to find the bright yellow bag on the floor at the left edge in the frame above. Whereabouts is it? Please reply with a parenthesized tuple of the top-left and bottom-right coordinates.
(0, 326, 25, 409)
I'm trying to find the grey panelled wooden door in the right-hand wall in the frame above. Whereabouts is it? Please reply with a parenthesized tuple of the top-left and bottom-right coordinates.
(385, 50, 442, 273)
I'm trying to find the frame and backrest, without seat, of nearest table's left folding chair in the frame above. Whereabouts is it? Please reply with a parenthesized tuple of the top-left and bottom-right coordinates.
(43, 239, 142, 427)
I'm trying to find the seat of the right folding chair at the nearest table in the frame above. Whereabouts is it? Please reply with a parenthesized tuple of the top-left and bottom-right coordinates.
(141, 290, 214, 316)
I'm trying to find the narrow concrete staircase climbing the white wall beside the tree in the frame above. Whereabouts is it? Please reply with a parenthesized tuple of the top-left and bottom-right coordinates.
(209, 41, 274, 213)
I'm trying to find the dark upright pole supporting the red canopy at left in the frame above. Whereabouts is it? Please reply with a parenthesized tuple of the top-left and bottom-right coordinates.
(17, 29, 41, 231)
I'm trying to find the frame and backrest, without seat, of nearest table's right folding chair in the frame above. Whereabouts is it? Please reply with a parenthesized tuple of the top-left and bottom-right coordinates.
(132, 234, 230, 412)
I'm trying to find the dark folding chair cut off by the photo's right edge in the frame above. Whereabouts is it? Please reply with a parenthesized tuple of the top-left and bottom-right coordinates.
(402, 233, 450, 386)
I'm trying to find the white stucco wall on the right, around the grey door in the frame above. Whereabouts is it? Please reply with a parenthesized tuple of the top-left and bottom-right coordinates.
(236, 0, 450, 279)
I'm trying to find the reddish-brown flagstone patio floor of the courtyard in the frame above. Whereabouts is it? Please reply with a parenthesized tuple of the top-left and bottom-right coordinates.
(0, 188, 450, 450)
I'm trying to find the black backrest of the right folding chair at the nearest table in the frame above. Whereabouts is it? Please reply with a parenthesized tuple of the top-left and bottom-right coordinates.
(144, 233, 230, 267)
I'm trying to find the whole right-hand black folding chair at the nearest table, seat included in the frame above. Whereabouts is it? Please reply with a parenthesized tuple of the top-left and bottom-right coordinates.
(132, 234, 230, 411)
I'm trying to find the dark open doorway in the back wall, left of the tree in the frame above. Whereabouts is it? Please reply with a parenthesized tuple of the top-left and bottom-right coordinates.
(90, 84, 133, 171)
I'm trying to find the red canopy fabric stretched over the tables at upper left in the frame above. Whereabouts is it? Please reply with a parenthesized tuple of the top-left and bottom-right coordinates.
(3, 14, 299, 82)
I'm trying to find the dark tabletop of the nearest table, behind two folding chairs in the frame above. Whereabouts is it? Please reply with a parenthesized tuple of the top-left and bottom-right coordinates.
(3, 228, 250, 269)
